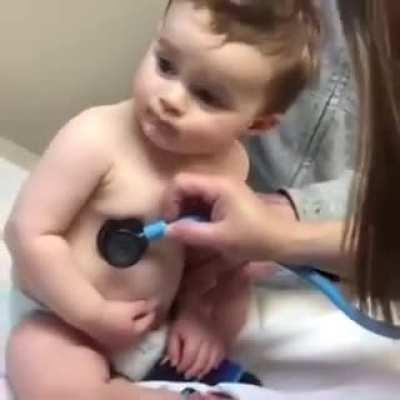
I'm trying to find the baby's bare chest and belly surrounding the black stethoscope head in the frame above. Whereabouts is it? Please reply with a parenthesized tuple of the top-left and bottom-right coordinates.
(70, 152, 183, 305)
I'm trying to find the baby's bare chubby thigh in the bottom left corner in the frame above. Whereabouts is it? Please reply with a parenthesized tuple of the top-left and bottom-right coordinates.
(6, 315, 109, 400)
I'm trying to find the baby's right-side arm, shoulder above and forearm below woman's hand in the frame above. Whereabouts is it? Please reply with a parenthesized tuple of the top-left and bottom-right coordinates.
(167, 143, 249, 377)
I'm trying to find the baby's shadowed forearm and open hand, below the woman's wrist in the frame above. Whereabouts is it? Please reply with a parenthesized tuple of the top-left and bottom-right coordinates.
(168, 253, 249, 378)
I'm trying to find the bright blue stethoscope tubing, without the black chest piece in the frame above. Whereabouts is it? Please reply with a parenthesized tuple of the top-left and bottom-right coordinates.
(143, 216, 400, 339)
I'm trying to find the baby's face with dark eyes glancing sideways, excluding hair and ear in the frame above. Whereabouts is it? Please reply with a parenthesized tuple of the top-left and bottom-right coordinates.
(134, 1, 271, 154)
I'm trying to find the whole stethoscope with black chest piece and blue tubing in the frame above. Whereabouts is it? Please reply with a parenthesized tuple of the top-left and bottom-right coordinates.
(97, 216, 400, 339)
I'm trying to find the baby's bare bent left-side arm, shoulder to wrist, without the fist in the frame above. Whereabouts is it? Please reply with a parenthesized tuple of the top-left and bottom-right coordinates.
(5, 110, 126, 338)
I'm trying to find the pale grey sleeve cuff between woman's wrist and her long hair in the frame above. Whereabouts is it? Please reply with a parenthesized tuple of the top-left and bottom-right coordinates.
(280, 170, 354, 221)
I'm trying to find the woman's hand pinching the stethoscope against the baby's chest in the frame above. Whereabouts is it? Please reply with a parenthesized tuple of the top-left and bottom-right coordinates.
(165, 174, 298, 261)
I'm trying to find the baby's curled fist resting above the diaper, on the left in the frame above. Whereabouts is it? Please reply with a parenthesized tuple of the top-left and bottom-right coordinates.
(85, 300, 157, 350)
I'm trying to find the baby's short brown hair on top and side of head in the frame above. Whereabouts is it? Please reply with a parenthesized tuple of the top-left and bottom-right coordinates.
(166, 0, 322, 113)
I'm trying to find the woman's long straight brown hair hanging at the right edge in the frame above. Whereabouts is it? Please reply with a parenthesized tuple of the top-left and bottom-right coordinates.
(338, 0, 400, 321)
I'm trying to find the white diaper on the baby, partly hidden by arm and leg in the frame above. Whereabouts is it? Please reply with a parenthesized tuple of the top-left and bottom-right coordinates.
(9, 287, 168, 382)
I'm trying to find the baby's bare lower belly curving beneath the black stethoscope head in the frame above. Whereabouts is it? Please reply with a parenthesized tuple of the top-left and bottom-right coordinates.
(68, 224, 184, 316)
